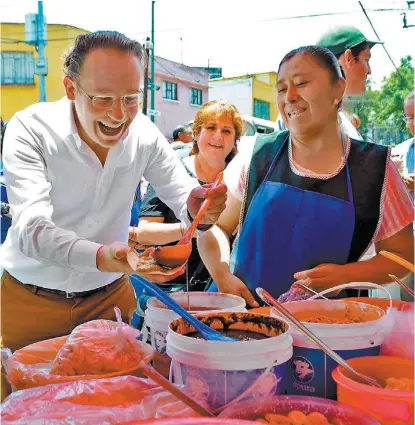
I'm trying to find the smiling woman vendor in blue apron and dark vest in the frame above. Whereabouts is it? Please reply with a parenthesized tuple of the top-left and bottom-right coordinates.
(198, 46, 414, 306)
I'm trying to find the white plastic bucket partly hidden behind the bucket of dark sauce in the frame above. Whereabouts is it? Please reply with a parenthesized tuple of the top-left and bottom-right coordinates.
(142, 292, 246, 378)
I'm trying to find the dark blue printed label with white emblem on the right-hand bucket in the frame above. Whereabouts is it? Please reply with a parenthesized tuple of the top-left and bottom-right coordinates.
(287, 346, 380, 400)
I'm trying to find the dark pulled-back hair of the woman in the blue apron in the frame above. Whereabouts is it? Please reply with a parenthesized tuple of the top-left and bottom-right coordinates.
(278, 46, 344, 109)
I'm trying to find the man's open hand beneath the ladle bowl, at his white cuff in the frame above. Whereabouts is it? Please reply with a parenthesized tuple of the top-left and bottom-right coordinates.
(97, 242, 134, 274)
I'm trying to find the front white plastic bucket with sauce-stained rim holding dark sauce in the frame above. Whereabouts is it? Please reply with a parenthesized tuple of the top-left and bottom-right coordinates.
(167, 312, 292, 410)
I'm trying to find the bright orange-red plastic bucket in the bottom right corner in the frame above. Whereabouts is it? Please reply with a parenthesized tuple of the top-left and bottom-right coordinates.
(333, 356, 414, 425)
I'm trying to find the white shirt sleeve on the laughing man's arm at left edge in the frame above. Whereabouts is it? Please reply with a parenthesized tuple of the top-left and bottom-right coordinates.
(3, 115, 101, 272)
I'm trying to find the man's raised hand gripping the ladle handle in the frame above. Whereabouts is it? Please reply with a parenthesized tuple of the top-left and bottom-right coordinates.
(187, 183, 227, 224)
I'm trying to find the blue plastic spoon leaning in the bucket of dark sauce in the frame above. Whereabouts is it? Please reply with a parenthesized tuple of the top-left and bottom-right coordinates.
(130, 274, 239, 342)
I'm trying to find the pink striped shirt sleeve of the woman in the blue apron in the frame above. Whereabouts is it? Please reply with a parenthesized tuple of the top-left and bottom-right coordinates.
(375, 160, 414, 242)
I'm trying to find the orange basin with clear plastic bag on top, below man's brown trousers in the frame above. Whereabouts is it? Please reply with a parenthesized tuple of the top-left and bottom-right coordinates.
(1, 309, 155, 390)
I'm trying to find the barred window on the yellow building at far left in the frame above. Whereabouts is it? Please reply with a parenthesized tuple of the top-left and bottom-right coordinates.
(0, 52, 35, 84)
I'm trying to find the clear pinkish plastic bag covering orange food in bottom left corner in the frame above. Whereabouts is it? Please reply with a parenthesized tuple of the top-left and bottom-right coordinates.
(0, 376, 203, 425)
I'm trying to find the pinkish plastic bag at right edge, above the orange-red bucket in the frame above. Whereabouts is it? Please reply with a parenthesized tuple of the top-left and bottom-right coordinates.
(380, 303, 415, 360)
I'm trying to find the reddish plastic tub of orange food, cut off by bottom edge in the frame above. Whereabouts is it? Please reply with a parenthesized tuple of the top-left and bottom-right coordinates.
(219, 395, 379, 425)
